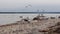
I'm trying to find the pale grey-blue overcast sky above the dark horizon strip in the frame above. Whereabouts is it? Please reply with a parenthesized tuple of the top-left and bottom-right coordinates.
(0, 0, 60, 12)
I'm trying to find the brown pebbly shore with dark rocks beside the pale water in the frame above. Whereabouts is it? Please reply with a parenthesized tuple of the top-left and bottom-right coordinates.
(0, 15, 60, 34)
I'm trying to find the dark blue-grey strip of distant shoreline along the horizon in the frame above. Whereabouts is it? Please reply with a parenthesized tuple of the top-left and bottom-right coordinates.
(0, 12, 60, 14)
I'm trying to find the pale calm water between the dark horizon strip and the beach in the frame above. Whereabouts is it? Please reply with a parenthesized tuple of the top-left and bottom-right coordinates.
(0, 14, 60, 25)
